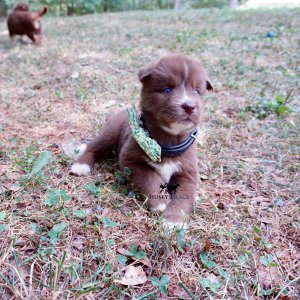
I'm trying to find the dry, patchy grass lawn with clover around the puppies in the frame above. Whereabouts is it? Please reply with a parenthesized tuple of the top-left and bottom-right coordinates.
(0, 9, 300, 299)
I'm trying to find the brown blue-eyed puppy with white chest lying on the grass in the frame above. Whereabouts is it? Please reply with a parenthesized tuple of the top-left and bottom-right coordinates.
(71, 54, 212, 227)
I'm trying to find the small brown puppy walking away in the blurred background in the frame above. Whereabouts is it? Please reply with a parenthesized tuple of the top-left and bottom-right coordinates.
(7, 3, 48, 44)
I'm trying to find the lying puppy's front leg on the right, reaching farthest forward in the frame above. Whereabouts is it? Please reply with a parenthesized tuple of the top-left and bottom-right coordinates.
(163, 173, 198, 228)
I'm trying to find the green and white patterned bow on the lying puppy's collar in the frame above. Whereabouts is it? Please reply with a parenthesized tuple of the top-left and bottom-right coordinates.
(127, 105, 161, 162)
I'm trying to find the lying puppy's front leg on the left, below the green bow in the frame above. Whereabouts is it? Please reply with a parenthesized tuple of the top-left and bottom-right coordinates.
(126, 163, 171, 211)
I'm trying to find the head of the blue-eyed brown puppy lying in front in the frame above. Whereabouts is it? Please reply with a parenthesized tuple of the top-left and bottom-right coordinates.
(138, 54, 213, 135)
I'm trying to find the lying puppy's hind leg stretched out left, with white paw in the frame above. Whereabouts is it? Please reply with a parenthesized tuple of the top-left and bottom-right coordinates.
(71, 111, 126, 175)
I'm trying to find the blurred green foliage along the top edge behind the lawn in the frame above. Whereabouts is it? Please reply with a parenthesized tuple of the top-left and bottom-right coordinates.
(0, 0, 237, 16)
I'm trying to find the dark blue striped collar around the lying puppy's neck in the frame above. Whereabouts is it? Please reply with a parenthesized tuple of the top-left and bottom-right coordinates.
(139, 113, 198, 157)
